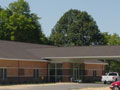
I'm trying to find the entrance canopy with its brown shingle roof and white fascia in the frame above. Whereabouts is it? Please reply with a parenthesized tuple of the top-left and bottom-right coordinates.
(41, 46, 120, 61)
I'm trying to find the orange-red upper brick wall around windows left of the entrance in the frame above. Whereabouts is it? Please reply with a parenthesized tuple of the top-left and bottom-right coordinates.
(0, 60, 48, 77)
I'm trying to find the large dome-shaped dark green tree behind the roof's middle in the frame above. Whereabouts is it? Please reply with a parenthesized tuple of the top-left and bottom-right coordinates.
(50, 9, 103, 46)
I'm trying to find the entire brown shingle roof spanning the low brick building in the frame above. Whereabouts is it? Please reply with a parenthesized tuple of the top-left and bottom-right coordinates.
(0, 40, 120, 60)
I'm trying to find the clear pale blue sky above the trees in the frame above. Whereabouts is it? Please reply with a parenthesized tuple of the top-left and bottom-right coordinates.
(0, 0, 120, 36)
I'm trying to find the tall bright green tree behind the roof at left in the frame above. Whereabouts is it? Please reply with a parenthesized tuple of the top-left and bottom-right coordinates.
(0, 0, 46, 43)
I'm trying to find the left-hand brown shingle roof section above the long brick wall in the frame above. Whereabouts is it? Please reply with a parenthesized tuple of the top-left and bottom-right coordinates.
(0, 40, 53, 60)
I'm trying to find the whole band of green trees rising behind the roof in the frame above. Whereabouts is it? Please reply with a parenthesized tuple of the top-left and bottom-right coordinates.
(0, 0, 120, 46)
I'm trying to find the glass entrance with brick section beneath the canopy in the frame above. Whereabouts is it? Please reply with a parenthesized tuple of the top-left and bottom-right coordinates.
(48, 63, 83, 82)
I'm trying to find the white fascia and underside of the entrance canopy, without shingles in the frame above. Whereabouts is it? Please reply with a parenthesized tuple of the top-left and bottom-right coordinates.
(42, 56, 120, 63)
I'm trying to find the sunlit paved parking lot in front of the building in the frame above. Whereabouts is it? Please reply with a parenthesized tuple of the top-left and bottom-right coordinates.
(0, 83, 106, 90)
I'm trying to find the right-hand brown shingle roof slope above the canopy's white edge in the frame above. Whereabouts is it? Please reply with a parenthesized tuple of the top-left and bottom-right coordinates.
(29, 46, 120, 57)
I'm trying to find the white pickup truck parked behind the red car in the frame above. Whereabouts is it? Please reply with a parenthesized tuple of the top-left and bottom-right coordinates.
(101, 72, 120, 84)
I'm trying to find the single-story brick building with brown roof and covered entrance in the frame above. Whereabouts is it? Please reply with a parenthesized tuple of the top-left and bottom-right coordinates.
(0, 40, 120, 83)
